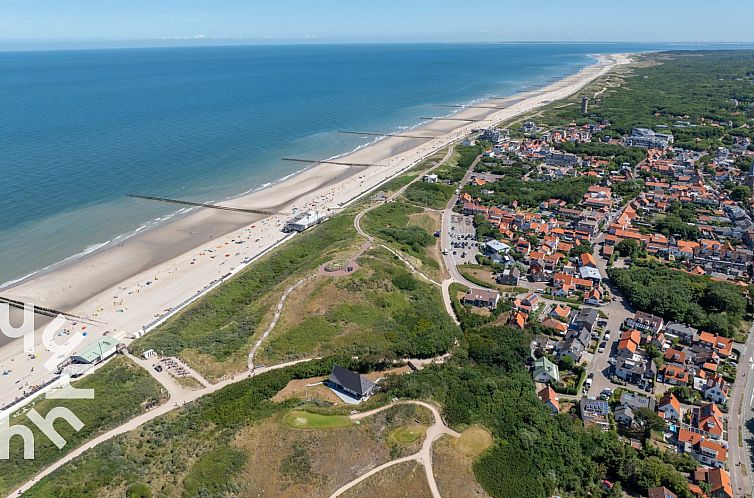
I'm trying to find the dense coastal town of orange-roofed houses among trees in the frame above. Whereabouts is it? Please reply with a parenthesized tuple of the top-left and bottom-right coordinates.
(434, 89, 754, 498)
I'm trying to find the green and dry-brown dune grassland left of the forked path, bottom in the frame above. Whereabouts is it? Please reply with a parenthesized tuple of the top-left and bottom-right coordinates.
(20, 357, 432, 498)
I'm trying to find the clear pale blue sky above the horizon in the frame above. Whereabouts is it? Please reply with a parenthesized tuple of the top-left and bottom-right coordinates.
(0, 0, 754, 46)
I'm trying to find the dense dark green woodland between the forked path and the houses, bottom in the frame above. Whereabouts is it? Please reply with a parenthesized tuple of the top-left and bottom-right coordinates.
(385, 326, 689, 498)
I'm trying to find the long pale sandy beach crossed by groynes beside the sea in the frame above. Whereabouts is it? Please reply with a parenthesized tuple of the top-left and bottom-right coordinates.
(0, 54, 629, 406)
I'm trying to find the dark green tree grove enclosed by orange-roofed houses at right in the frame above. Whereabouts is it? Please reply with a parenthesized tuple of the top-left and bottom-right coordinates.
(608, 262, 747, 337)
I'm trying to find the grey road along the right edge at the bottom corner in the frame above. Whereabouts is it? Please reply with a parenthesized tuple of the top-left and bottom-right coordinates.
(728, 327, 754, 497)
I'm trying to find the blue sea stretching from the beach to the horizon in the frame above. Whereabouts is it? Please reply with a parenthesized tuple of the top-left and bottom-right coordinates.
(0, 43, 748, 287)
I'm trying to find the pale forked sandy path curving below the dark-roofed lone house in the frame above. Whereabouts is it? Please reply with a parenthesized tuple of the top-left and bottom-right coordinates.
(330, 400, 461, 498)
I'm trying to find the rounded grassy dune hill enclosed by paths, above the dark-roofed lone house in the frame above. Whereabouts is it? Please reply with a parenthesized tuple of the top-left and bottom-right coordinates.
(257, 248, 460, 364)
